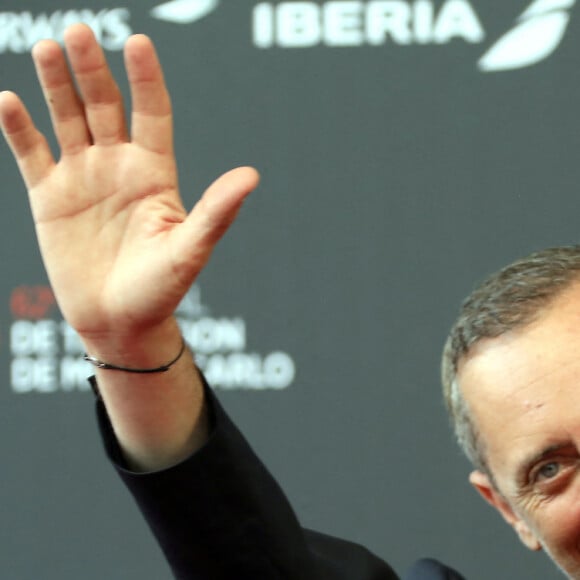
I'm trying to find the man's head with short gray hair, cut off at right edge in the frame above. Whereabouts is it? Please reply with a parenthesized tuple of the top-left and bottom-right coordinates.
(442, 246, 580, 578)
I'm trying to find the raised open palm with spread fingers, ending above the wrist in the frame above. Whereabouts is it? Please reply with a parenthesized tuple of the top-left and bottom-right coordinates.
(0, 25, 257, 339)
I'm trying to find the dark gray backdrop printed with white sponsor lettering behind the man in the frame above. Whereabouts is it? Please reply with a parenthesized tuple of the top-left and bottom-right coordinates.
(0, 0, 580, 580)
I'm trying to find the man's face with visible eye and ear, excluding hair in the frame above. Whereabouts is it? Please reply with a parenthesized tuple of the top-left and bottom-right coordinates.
(458, 284, 580, 579)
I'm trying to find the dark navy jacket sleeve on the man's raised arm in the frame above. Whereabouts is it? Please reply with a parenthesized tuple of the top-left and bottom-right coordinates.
(97, 374, 397, 580)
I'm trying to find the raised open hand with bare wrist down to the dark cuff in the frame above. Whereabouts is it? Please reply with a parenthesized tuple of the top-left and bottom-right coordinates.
(0, 24, 258, 469)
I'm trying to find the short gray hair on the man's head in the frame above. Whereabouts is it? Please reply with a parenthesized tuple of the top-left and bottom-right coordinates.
(441, 245, 580, 479)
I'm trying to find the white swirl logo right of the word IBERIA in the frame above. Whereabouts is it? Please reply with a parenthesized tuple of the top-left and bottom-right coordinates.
(478, 0, 576, 72)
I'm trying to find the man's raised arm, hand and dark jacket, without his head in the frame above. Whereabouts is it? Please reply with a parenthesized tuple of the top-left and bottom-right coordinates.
(0, 25, 460, 580)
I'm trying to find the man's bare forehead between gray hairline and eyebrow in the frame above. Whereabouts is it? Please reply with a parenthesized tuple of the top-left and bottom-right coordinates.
(458, 285, 580, 480)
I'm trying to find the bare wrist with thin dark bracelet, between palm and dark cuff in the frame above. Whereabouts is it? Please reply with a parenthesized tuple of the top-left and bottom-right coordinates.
(82, 318, 208, 471)
